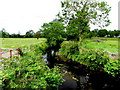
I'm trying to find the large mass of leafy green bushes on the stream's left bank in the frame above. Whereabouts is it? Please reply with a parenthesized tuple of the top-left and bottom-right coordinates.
(2, 44, 63, 89)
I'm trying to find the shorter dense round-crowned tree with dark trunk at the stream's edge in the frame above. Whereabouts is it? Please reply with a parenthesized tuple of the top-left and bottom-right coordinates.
(40, 21, 65, 67)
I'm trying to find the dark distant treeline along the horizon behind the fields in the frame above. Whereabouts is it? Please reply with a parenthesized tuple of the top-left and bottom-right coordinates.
(0, 28, 120, 39)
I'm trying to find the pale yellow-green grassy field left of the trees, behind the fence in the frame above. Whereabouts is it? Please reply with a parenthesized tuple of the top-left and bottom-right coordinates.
(0, 38, 46, 49)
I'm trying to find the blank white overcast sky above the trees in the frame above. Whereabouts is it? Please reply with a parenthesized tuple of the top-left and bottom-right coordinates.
(0, 0, 120, 34)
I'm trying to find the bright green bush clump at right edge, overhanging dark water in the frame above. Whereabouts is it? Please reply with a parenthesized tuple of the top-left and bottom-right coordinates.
(104, 60, 120, 76)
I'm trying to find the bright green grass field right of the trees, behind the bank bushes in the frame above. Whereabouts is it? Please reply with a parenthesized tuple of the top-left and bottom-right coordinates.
(83, 37, 118, 53)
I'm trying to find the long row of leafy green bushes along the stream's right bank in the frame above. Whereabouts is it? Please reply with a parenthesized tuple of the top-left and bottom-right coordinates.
(60, 41, 120, 76)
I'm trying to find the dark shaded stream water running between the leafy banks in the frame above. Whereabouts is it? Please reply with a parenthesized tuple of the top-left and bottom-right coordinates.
(43, 52, 120, 90)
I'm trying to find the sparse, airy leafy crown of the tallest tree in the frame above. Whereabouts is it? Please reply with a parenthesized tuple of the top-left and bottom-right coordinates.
(57, 0, 111, 39)
